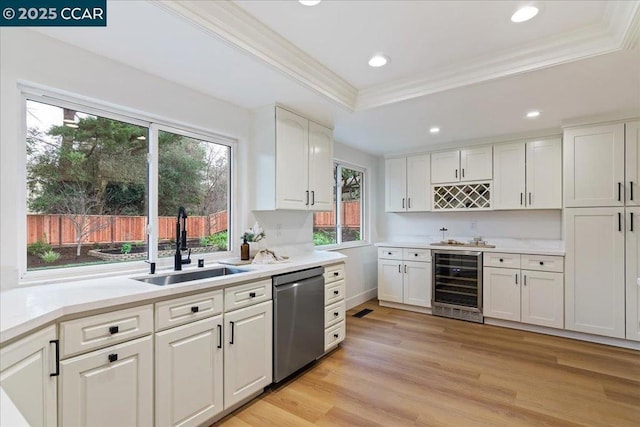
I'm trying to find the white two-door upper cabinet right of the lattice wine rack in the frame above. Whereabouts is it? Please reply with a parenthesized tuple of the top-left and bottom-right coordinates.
(493, 138, 562, 209)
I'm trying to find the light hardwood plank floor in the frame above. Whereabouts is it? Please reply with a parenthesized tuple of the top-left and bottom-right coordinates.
(217, 300, 640, 427)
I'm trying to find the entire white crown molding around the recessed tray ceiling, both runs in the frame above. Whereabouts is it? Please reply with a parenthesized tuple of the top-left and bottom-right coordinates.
(152, 0, 640, 111)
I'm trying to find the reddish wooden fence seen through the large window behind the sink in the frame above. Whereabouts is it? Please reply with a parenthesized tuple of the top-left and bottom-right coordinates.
(27, 211, 227, 246)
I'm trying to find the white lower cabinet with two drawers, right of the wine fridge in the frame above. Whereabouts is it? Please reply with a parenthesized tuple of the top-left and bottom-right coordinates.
(482, 253, 564, 328)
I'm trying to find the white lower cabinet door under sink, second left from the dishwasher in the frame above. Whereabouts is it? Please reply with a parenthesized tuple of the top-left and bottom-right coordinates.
(155, 314, 223, 426)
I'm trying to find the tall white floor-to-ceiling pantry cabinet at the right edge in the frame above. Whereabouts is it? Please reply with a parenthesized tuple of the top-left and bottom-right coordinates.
(563, 121, 640, 341)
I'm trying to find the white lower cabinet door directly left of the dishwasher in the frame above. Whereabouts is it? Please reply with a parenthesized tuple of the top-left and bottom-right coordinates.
(224, 301, 273, 409)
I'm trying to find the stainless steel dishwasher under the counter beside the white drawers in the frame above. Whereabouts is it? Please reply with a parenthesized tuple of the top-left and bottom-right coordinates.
(273, 267, 324, 383)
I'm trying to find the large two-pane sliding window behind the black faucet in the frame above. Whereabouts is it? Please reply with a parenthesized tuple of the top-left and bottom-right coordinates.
(24, 96, 232, 271)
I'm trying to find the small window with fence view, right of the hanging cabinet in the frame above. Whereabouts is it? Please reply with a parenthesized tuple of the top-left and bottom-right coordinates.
(313, 162, 366, 246)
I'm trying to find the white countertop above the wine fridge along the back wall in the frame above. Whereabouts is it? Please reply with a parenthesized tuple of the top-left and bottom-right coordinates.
(376, 237, 565, 256)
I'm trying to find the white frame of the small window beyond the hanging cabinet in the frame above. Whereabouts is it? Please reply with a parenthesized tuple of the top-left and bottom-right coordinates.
(312, 159, 371, 250)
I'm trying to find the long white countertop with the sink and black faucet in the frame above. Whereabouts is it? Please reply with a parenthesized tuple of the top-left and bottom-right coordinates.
(0, 251, 346, 343)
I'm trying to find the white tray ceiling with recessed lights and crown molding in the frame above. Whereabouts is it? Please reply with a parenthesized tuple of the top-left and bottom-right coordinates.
(33, 0, 640, 154)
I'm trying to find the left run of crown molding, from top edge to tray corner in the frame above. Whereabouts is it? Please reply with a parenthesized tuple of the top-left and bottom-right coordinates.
(152, 0, 358, 111)
